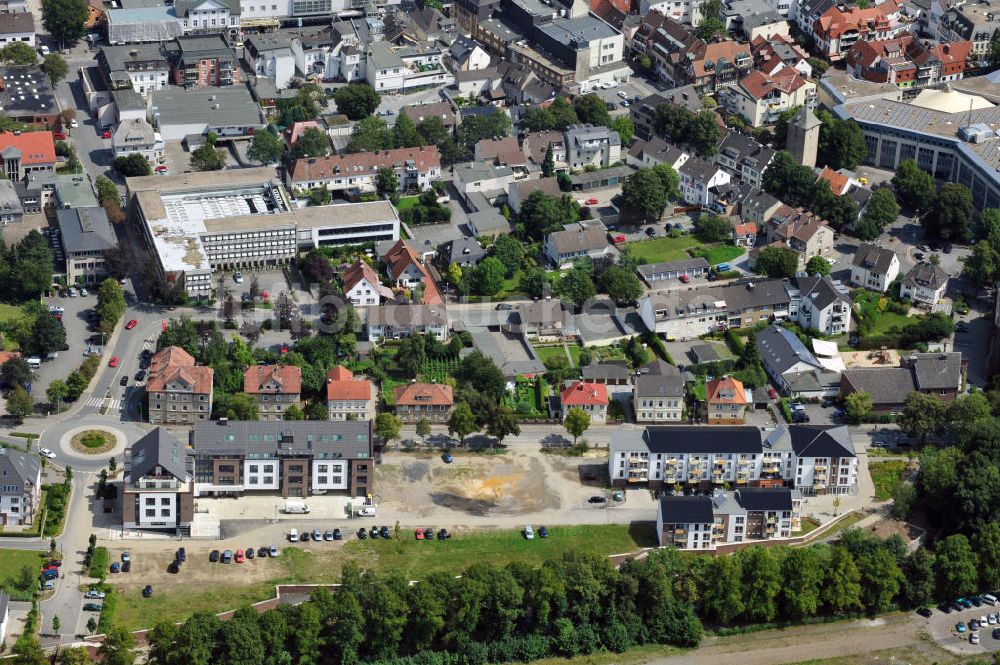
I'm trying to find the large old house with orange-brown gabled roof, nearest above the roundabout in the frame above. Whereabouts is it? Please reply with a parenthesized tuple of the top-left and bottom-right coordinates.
(146, 346, 214, 425)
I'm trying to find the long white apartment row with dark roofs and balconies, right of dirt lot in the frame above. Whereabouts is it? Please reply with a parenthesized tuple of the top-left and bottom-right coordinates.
(608, 425, 857, 495)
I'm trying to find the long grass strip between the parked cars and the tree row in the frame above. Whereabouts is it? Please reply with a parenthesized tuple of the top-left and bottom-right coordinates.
(115, 524, 656, 629)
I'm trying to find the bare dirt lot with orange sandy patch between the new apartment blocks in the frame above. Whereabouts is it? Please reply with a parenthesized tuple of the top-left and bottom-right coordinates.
(376, 450, 607, 520)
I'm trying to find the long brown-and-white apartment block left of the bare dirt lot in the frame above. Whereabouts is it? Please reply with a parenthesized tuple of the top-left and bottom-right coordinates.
(191, 419, 375, 497)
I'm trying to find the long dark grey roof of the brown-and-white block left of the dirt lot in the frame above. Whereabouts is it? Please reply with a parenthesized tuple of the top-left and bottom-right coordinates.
(191, 420, 372, 459)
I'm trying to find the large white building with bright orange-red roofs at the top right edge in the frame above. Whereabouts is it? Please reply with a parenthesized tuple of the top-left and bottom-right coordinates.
(812, 0, 906, 60)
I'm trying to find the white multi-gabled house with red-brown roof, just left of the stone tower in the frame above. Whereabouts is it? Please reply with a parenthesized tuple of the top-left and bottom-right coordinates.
(723, 67, 816, 127)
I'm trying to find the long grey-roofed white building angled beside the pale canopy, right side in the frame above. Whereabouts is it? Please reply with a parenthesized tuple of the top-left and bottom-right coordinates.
(756, 323, 842, 399)
